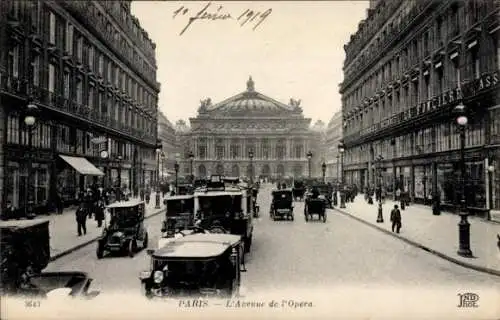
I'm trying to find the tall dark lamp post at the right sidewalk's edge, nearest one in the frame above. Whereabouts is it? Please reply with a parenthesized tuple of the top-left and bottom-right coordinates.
(453, 103, 472, 258)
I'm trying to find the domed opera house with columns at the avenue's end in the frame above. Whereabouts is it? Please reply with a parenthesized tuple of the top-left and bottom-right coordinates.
(180, 77, 321, 178)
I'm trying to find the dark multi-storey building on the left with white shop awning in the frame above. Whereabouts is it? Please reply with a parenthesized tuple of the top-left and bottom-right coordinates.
(0, 0, 160, 209)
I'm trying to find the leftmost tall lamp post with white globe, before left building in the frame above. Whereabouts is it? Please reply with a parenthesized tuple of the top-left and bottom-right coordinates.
(24, 103, 39, 219)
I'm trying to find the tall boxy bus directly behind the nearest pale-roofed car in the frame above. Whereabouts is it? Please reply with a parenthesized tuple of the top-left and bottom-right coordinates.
(194, 175, 253, 252)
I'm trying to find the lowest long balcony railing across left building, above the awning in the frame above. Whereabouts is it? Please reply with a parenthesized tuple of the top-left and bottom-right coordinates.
(0, 73, 156, 144)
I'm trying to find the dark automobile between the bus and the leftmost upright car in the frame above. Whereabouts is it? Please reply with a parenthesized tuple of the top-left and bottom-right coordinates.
(158, 195, 195, 248)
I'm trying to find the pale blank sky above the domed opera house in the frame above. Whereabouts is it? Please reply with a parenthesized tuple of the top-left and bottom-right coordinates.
(132, 1, 368, 123)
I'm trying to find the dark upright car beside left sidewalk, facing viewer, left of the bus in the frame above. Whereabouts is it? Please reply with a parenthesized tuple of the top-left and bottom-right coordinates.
(96, 200, 148, 259)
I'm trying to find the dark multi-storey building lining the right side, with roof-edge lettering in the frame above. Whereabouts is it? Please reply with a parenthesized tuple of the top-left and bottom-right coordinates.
(340, 0, 500, 213)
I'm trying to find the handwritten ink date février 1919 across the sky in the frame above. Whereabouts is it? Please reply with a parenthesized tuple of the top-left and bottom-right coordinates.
(173, 2, 273, 35)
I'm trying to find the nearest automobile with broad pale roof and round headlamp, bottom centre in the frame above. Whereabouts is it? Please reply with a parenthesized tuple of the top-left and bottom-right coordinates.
(140, 233, 246, 299)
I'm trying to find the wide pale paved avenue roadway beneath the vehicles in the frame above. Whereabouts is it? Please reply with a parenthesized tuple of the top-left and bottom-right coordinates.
(46, 182, 498, 295)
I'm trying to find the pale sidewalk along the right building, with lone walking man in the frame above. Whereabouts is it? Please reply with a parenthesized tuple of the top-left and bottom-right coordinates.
(335, 194, 500, 276)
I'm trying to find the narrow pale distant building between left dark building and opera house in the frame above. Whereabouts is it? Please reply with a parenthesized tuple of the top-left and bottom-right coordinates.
(158, 112, 180, 178)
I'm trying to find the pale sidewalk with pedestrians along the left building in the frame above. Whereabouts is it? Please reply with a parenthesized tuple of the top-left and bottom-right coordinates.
(45, 196, 165, 261)
